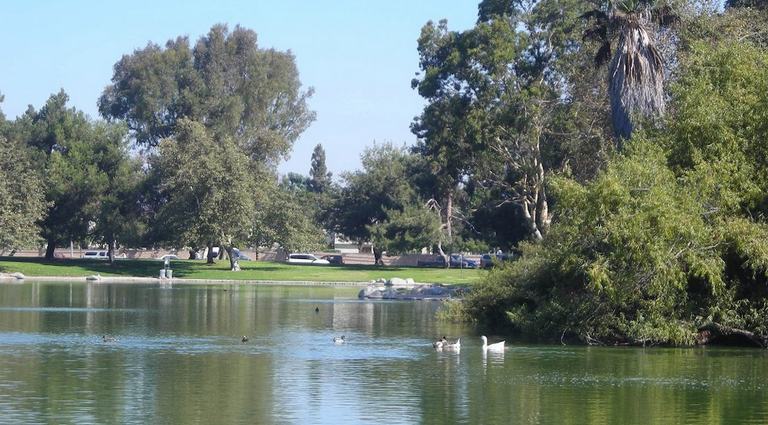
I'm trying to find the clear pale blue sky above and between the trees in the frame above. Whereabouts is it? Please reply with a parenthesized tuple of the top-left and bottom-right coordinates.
(0, 0, 479, 175)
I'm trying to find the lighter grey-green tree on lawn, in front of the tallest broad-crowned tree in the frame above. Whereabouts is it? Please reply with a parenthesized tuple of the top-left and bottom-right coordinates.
(152, 119, 255, 271)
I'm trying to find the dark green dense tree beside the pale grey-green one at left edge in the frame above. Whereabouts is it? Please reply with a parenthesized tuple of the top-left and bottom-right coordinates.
(6, 91, 140, 259)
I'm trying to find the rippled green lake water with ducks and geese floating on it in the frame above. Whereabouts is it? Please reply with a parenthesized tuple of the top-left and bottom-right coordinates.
(0, 283, 768, 424)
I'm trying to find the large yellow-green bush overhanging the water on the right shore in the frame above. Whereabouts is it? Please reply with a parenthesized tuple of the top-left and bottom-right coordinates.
(443, 44, 768, 346)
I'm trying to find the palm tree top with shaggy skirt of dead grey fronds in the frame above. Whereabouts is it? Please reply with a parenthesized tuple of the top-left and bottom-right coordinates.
(582, 0, 675, 142)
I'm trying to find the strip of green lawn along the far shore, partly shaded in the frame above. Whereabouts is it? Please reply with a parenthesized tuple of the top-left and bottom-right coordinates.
(0, 257, 485, 284)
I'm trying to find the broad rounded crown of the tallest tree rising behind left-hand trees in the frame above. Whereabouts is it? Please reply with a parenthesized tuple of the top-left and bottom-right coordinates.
(99, 25, 315, 164)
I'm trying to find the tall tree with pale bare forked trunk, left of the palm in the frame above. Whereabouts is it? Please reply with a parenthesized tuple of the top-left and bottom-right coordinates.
(412, 3, 559, 240)
